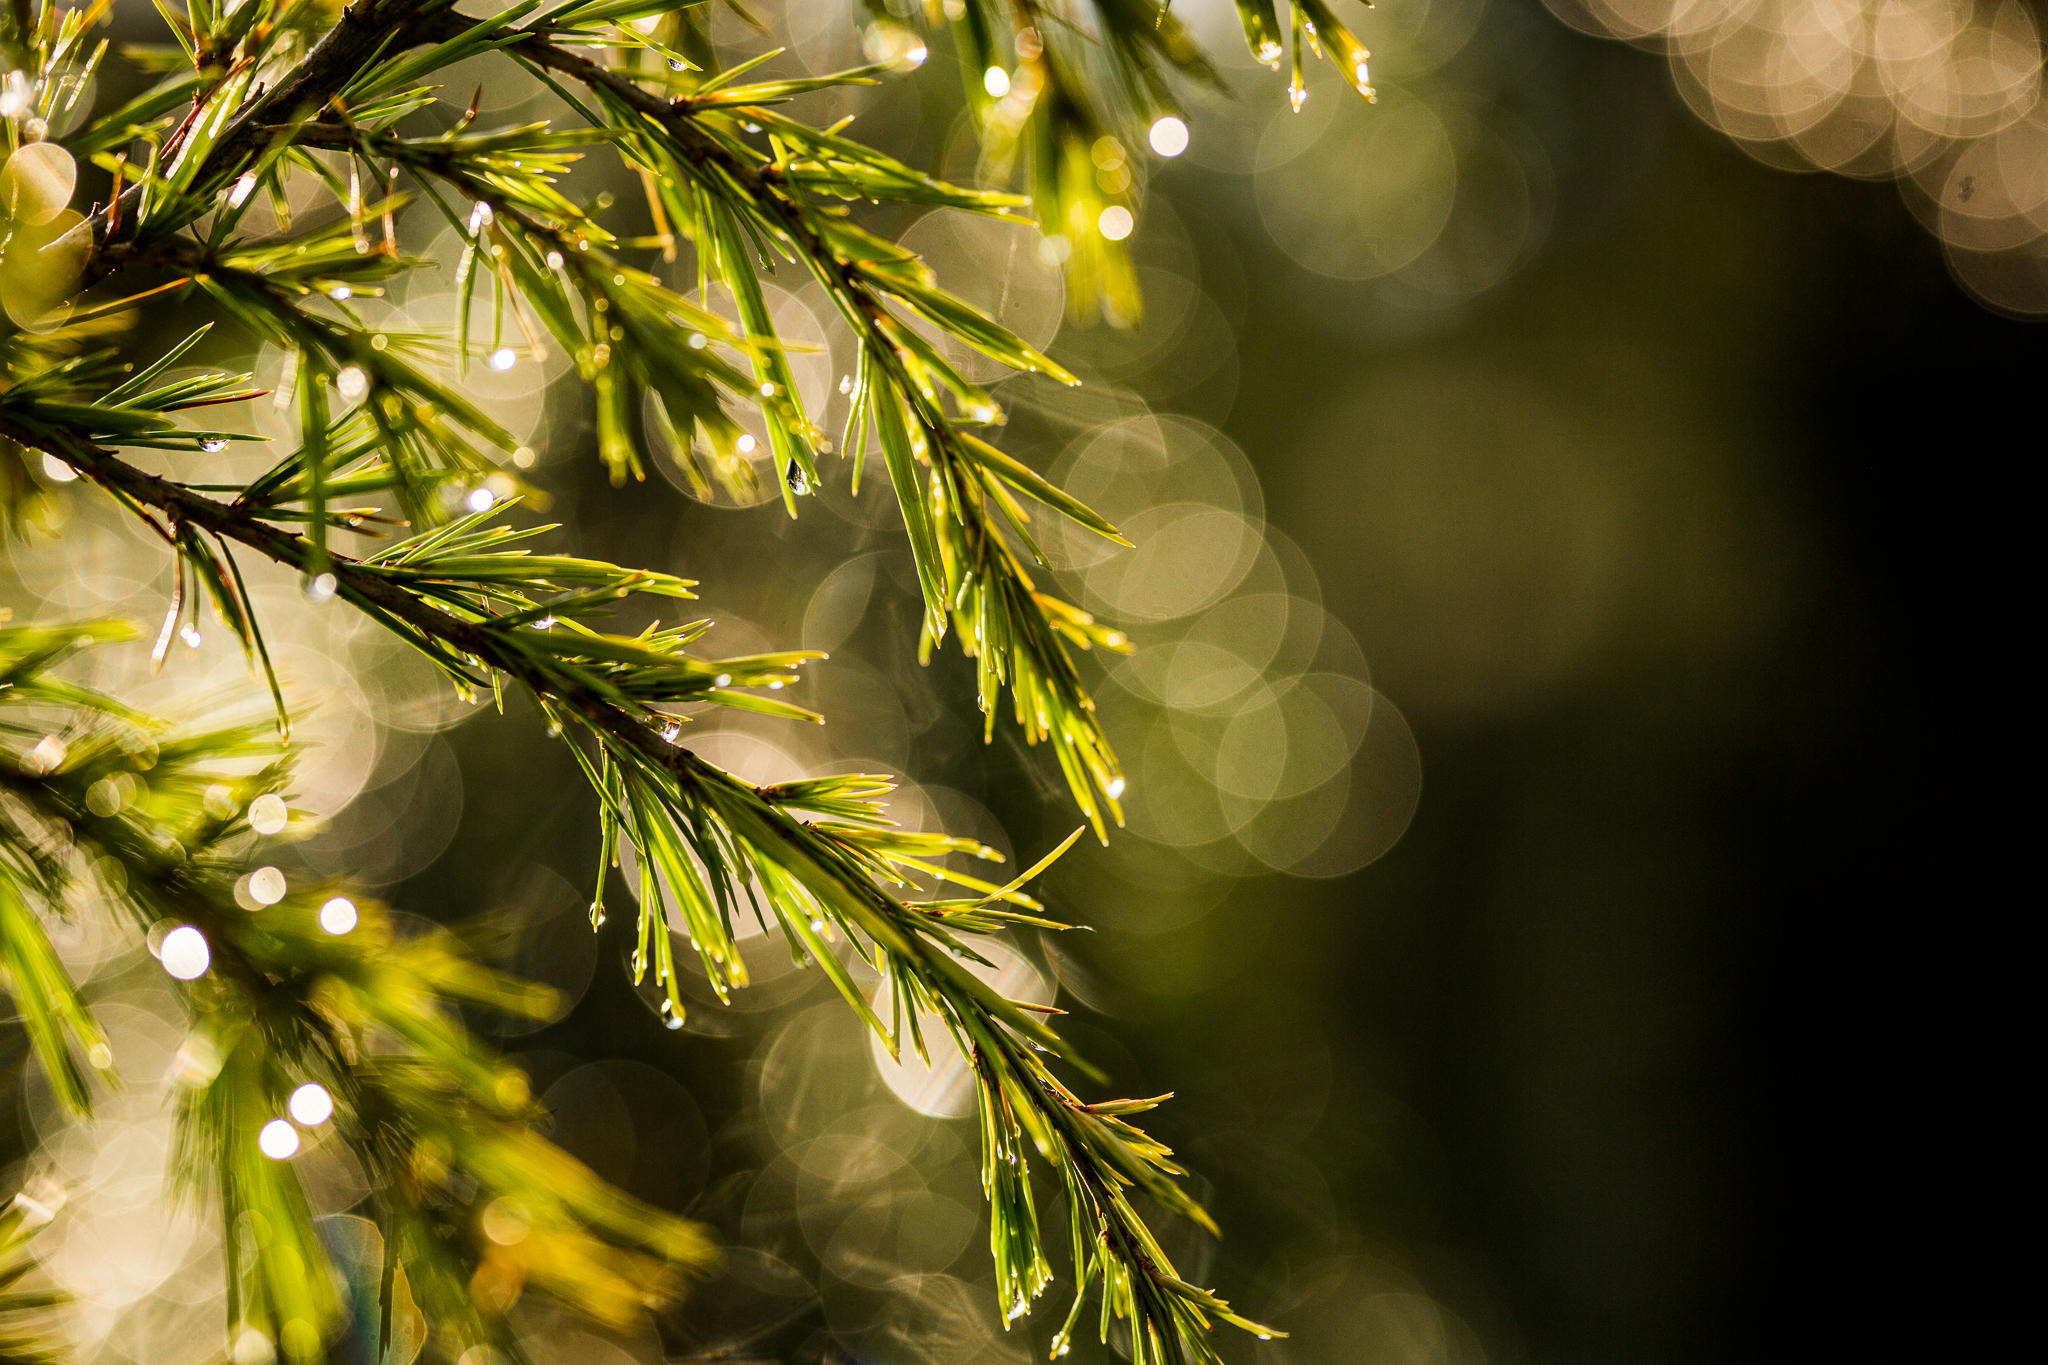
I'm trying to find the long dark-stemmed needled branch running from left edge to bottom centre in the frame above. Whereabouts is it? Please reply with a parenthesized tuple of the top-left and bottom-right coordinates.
(0, 420, 1266, 1363)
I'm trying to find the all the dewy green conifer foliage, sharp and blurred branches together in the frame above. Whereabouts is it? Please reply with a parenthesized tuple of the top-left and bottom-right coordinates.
(0, 0, 1370, 1365)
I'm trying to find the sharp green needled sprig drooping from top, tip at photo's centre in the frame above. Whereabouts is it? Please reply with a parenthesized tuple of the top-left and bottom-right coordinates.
(462, 7, 1126, 837)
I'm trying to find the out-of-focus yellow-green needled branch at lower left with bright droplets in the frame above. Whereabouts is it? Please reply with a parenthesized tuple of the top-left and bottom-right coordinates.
(0, 624, 711, 1361)
